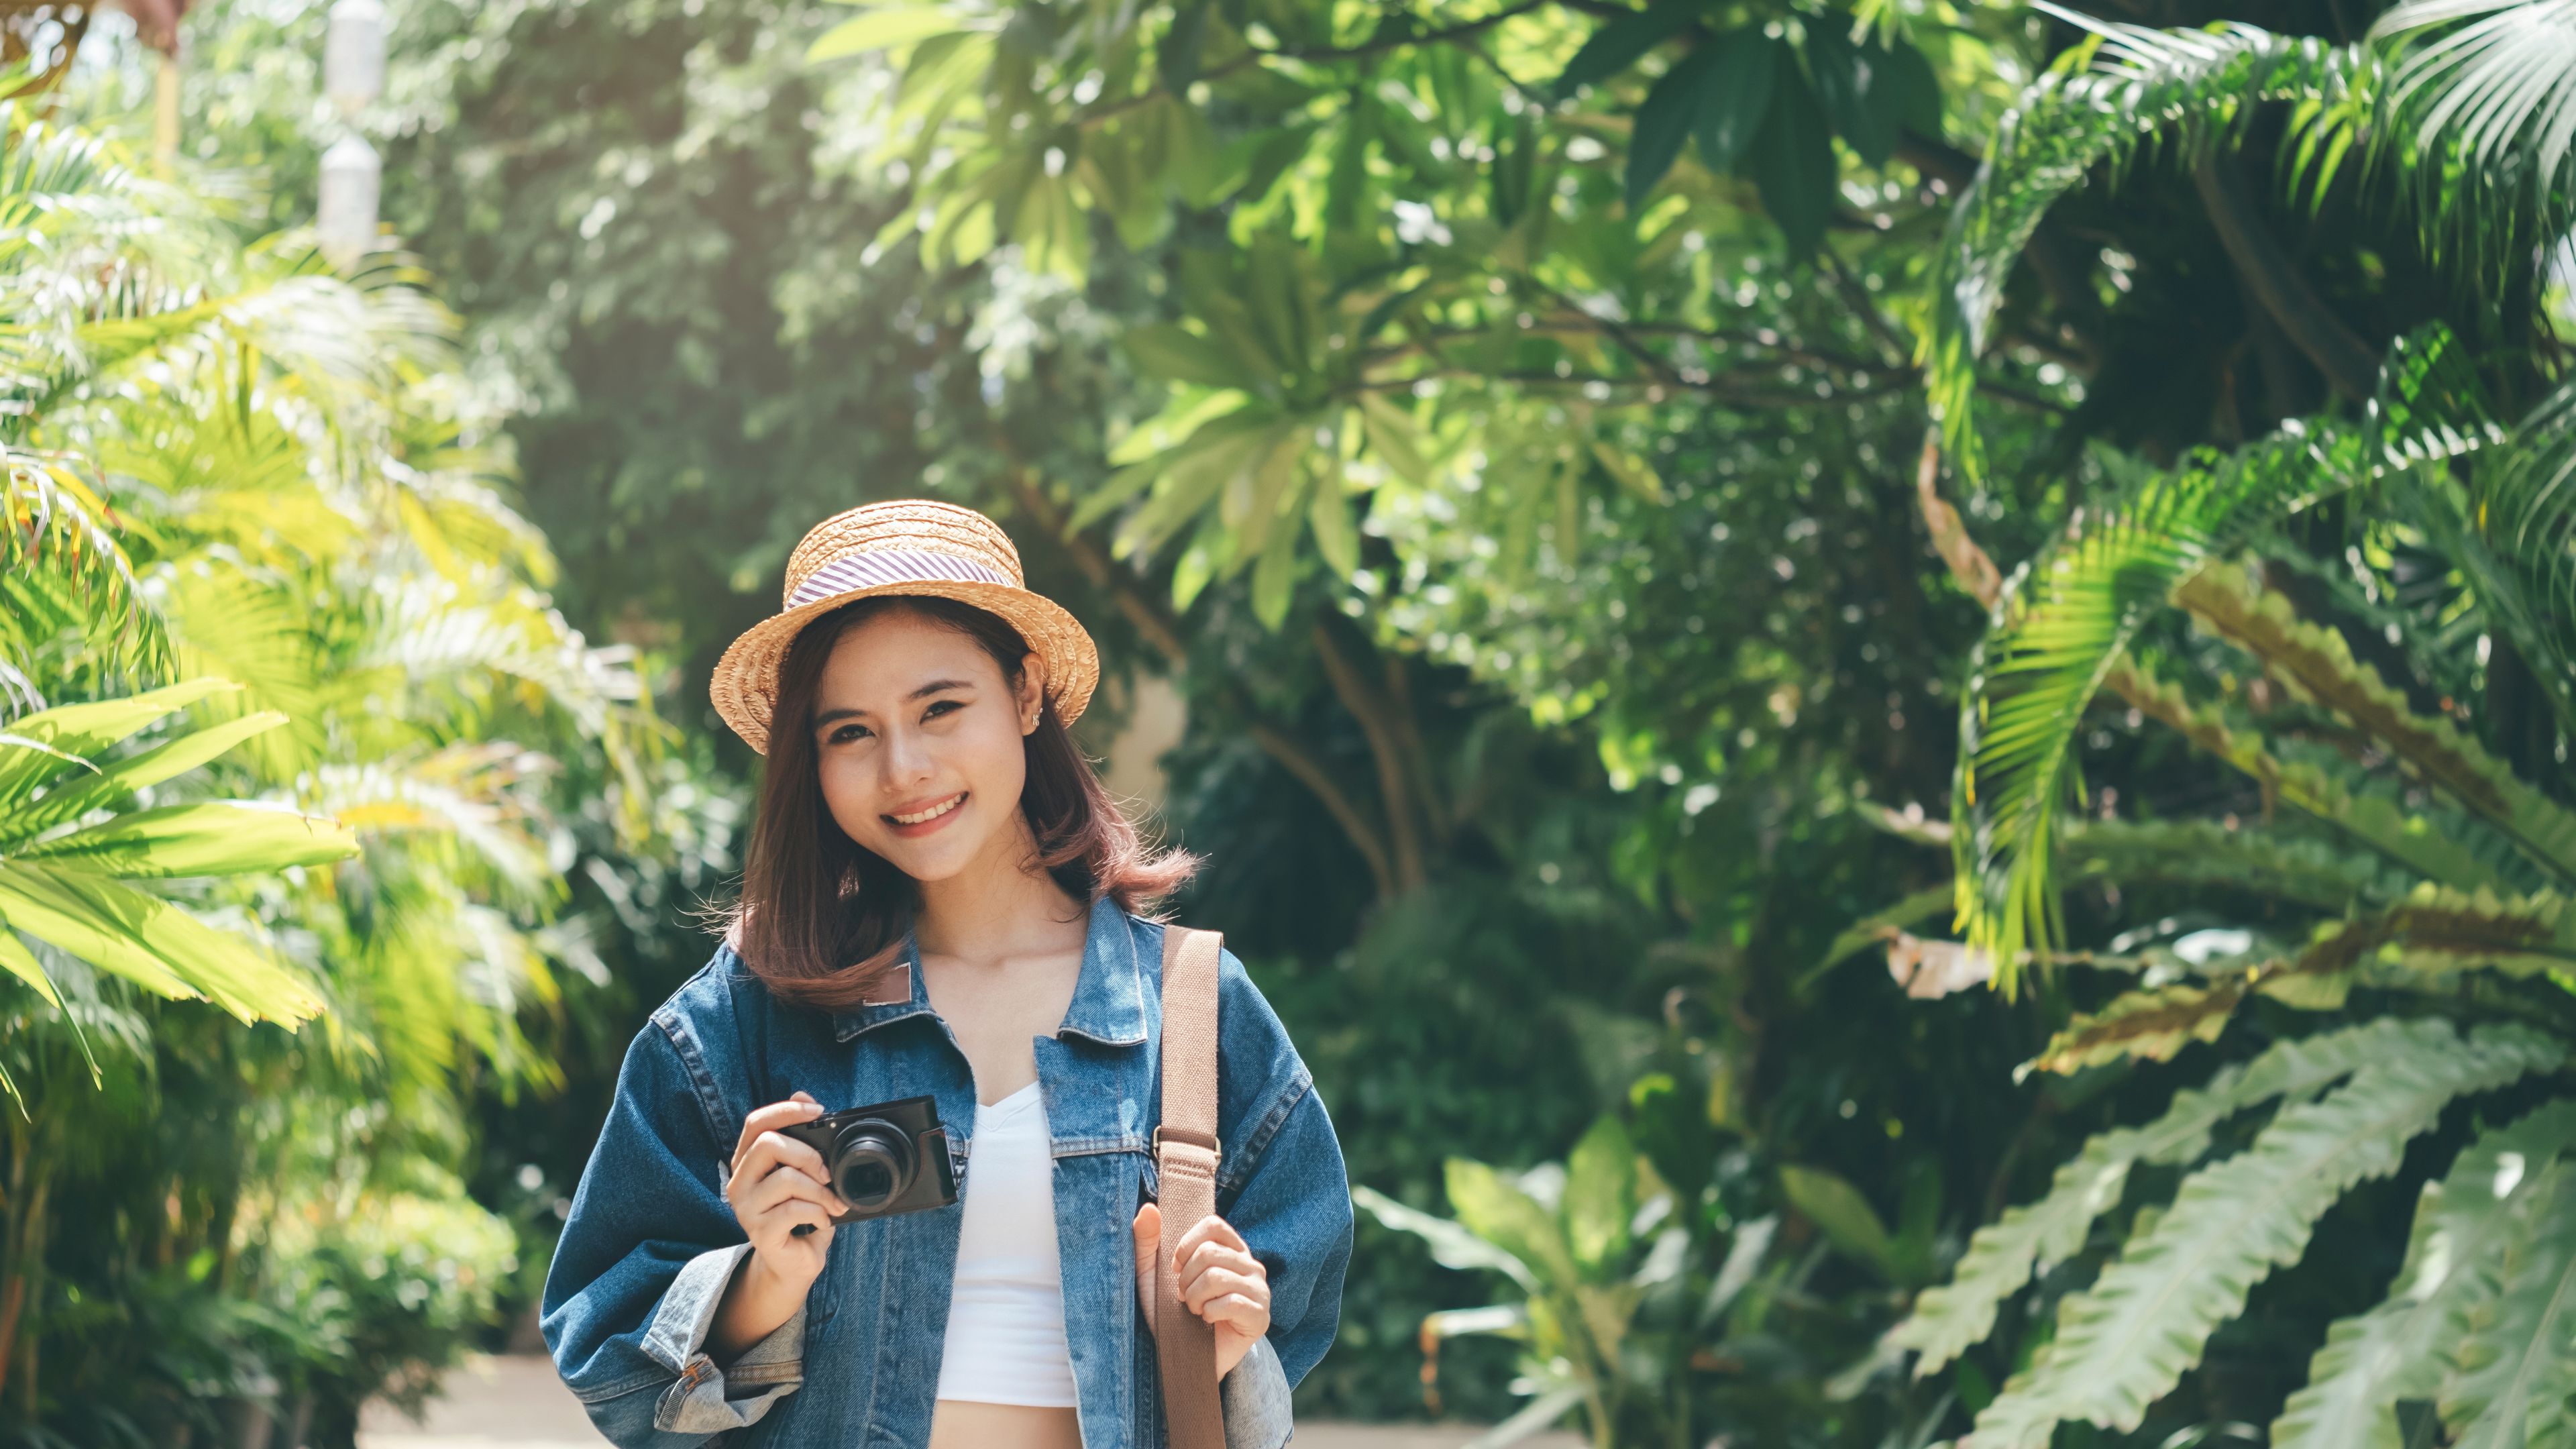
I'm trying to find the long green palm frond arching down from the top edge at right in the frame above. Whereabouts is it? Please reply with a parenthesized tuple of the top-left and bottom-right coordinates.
(1922, 8, 2355, 477)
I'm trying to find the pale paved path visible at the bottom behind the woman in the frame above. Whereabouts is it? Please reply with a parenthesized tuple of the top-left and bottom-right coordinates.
(358, 1356, 1579, 1449)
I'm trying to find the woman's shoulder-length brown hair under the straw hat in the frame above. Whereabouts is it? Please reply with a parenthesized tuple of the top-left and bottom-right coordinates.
(729, 593, 1200, 1011)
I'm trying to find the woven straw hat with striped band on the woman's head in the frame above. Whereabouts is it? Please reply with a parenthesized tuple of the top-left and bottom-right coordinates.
(708, 498, 1100, 755)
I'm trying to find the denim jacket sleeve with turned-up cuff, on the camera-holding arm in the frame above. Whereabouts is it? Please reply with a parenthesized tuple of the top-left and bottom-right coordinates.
(539, 1013, 804, 1449)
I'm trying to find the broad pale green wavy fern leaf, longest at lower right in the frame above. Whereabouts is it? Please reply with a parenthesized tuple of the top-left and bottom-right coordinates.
(1963, 1021, 2566, 1449)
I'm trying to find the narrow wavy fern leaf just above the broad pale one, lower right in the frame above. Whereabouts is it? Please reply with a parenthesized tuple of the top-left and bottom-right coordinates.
(1891, 1021, 2452, 1377)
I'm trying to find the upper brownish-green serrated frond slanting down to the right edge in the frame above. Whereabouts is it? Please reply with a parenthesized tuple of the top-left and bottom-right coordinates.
(2174, 565, 2576, 884)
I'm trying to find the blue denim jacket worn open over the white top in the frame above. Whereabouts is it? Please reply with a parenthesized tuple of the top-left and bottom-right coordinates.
(541, 898, 1352, 1449)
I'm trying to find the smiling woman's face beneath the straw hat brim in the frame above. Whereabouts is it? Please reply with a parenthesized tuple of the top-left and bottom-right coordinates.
(814, 608, 1046, 881)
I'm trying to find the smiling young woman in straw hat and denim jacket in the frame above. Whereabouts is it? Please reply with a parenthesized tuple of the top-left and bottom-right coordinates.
(541, 500, 1350, 1449)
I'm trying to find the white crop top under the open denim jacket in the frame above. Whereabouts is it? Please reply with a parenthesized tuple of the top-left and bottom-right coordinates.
(938, 1083, 1074, 1408)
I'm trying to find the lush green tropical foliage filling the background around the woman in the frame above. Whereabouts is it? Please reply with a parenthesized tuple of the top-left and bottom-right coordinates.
(15, 0, 2576, 1449)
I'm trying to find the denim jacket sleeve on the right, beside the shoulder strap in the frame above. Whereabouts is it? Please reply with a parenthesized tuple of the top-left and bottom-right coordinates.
(1216, 951, 1352, 1390)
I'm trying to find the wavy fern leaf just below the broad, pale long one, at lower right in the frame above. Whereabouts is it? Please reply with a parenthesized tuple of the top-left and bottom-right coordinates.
(2272, 1101, 2576, 1449)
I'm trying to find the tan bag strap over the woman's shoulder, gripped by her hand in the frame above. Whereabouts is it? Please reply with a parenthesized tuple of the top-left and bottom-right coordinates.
(1154, 926, 1226, 1449)
